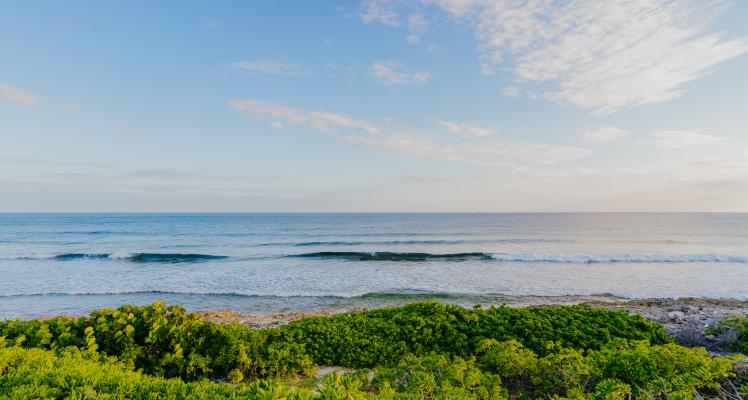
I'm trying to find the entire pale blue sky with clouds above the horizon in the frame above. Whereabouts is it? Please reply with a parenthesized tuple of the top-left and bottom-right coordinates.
(0, 0, 748, 212)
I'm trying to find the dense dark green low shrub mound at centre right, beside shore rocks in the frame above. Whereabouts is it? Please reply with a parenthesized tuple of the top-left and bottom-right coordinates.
(278, 303, 672, 368)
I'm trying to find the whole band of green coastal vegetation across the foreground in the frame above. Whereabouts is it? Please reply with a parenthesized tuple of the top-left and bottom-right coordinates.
(0, 303, 738, 399)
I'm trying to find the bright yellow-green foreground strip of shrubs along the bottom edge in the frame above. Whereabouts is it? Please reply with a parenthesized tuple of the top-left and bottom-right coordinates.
(0, 339, 737, 400)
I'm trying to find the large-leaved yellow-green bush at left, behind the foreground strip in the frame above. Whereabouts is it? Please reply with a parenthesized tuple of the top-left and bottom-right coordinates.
(0, 303, 313, 380)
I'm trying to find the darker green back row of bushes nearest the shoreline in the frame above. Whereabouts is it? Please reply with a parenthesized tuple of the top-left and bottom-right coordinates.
(0, 303, 671, 380)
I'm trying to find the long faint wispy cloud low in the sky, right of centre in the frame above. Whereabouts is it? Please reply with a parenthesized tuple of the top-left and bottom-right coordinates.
(345, 134, 592, 169)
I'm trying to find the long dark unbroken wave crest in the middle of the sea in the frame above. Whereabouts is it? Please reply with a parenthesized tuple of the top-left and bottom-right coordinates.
(289, 251, 492, 262)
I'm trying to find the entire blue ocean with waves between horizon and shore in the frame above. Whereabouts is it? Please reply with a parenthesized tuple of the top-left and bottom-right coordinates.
(0, 213, 748, 319)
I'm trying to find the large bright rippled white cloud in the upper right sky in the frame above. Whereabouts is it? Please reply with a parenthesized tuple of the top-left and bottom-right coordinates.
(367, 0, 748, 113)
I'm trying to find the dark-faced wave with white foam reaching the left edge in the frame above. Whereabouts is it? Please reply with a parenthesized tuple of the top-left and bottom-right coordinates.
(0, 253, 228, 263)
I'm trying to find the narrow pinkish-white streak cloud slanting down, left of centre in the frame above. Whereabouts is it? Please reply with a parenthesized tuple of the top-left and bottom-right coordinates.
(229, 99, 379, 133)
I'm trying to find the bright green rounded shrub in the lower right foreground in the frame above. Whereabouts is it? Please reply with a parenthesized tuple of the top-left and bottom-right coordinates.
(478, 340, 735, 398)
